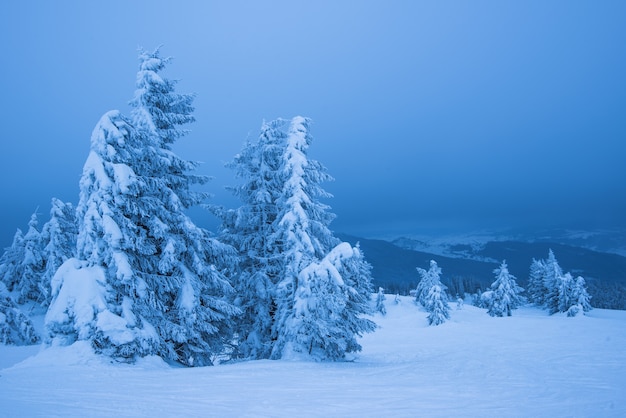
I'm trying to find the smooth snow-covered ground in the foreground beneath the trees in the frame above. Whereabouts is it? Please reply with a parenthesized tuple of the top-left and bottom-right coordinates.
(0, 296, 626, 417)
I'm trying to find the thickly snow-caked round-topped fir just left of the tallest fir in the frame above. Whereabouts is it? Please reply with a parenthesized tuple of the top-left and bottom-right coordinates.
(46, 111, 160, 359)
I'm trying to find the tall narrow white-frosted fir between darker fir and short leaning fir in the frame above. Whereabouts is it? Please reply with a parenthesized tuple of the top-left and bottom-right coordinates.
(271, 117, 339, 358)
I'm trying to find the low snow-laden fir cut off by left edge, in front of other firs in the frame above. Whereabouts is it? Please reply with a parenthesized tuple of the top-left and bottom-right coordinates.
(0, 282, 39, 345)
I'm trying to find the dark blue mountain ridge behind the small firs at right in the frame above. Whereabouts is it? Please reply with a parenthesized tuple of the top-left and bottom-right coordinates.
(336, 234, 626, 309)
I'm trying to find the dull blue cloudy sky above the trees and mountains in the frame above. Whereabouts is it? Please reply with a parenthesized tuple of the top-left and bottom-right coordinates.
(0, 0, 626, 246)
